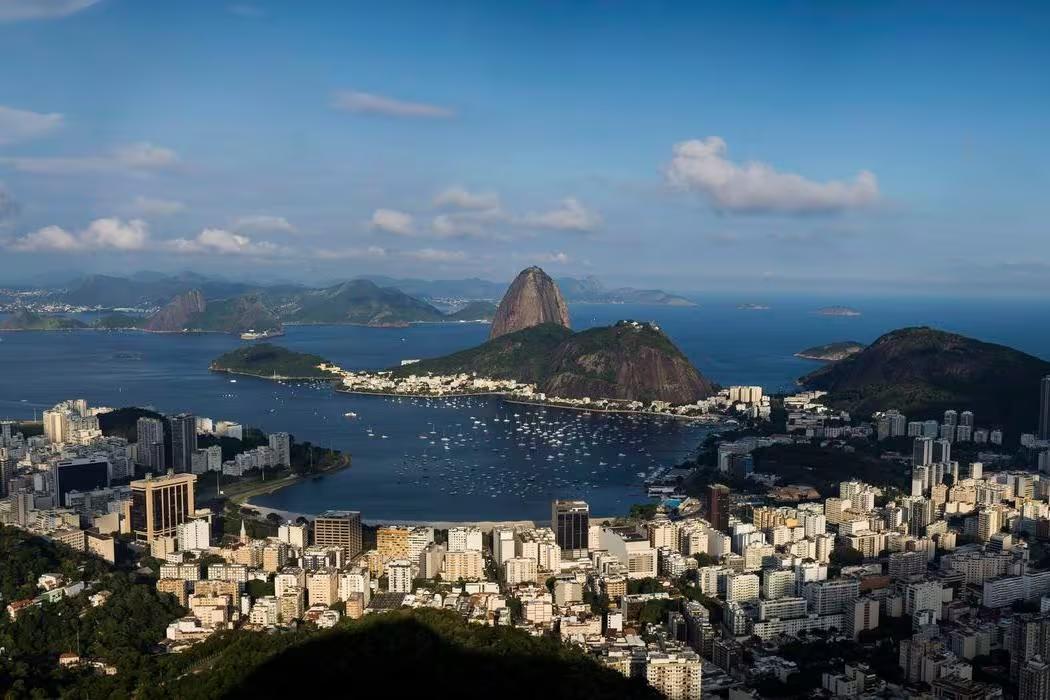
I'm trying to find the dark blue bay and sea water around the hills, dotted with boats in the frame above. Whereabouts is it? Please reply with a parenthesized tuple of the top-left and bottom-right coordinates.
(0, 298, 1050, 519)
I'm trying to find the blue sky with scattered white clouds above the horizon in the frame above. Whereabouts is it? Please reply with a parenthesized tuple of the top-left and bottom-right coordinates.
(0, 0, 1050, 296)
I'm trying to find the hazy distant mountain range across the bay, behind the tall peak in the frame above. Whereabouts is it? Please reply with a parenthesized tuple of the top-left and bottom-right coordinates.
(4, 273, 692, 333)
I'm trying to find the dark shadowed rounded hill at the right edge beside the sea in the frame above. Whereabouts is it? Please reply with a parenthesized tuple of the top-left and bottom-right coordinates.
(799, 327, 1050, 438)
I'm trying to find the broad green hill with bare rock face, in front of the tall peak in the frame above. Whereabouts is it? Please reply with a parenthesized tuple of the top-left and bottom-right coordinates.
(395, 321, 714, 404)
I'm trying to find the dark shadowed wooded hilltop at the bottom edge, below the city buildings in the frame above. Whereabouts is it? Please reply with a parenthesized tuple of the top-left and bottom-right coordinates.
(164, 610, 660, 700)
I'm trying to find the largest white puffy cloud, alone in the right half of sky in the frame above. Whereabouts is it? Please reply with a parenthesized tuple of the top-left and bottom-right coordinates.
(665, 136, 879, 214)
